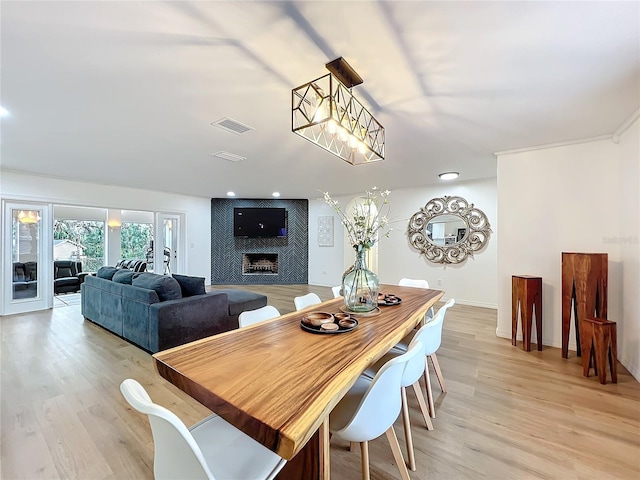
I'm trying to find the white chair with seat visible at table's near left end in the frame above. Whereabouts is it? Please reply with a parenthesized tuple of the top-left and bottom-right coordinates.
(120, 378, 286, 480)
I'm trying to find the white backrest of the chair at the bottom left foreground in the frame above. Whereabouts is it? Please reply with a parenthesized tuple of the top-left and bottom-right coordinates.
(120, 378, 214, 480)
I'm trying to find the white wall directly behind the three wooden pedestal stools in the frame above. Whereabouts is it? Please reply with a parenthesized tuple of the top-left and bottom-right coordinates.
(497, 121, 640, 378)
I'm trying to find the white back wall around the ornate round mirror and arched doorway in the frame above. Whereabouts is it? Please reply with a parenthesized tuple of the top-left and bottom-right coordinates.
(309, 179, 498, 308)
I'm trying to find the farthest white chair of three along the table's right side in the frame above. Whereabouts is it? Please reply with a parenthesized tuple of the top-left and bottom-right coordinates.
(392, 298, 456, 418)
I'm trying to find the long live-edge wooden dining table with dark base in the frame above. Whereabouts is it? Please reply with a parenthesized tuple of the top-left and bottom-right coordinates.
(153, 285, 443, 480)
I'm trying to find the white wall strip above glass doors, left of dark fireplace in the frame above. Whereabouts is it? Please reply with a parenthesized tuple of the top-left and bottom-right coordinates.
(0, 171, 211, 284)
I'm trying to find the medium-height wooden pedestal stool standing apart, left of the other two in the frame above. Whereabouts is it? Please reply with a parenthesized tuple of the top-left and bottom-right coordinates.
(511, 275, 542, 352)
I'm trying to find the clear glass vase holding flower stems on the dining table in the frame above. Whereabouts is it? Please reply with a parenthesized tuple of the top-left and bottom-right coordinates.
(342, 246, 380, 313)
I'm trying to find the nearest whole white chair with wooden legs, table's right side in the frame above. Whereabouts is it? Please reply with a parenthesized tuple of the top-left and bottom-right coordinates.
(329, 341, 424, 480)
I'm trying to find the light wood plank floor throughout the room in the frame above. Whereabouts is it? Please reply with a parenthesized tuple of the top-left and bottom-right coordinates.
(0, 285, 640, 480)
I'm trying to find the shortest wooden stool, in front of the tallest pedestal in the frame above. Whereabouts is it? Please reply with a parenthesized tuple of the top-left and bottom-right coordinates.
(582, 318, 618, 385)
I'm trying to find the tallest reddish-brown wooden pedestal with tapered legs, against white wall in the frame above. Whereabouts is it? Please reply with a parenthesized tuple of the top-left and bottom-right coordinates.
(562, 252, 608, 358)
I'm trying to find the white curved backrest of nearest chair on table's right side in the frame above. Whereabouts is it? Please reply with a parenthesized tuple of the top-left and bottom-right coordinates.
(334, 341, 424, 442)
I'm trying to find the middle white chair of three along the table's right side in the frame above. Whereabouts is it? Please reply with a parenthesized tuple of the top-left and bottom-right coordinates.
(363, 325, 433, 471)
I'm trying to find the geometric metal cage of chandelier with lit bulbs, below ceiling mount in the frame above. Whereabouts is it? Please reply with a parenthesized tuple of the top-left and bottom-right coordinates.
(291, 68, 385, 165)
